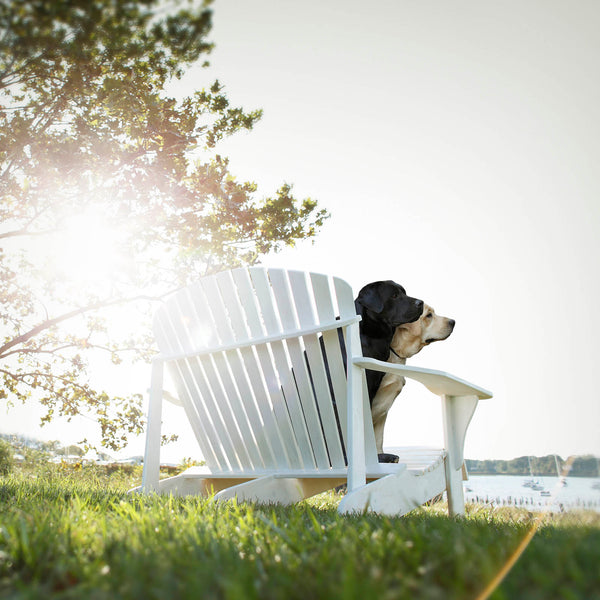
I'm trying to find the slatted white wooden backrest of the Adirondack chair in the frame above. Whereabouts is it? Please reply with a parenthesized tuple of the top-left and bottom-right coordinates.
(154, 267, 377, 472)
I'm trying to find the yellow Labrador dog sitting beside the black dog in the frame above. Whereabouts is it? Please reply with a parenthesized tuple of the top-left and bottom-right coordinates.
(371, 304, 456, 462)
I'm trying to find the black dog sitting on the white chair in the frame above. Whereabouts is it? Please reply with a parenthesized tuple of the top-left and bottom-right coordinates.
(354, 280, 423, 403)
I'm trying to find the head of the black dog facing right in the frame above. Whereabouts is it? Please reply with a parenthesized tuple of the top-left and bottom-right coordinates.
(356, 280, 423, 327)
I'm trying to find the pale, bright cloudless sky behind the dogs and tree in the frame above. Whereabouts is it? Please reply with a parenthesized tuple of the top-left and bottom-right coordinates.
(0, 0, 600, 460)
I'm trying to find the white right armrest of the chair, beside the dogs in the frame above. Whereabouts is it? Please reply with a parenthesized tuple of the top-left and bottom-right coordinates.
(352, 356, 492, 400)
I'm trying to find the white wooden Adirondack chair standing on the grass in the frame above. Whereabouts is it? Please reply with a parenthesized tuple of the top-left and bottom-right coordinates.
(137, 268, 491, 515)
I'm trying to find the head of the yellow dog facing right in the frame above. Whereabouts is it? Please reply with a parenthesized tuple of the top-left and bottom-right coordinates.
(390, 304, 456, 358)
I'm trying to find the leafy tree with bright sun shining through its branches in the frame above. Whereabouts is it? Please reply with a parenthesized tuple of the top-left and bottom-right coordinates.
(0, 0, 327, 449)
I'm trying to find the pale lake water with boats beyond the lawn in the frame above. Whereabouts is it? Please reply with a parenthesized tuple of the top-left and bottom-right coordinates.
(464, 474, 600, 512)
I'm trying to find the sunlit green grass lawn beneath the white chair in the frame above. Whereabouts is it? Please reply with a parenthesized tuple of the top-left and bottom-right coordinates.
(0, 467, 600, 600)
